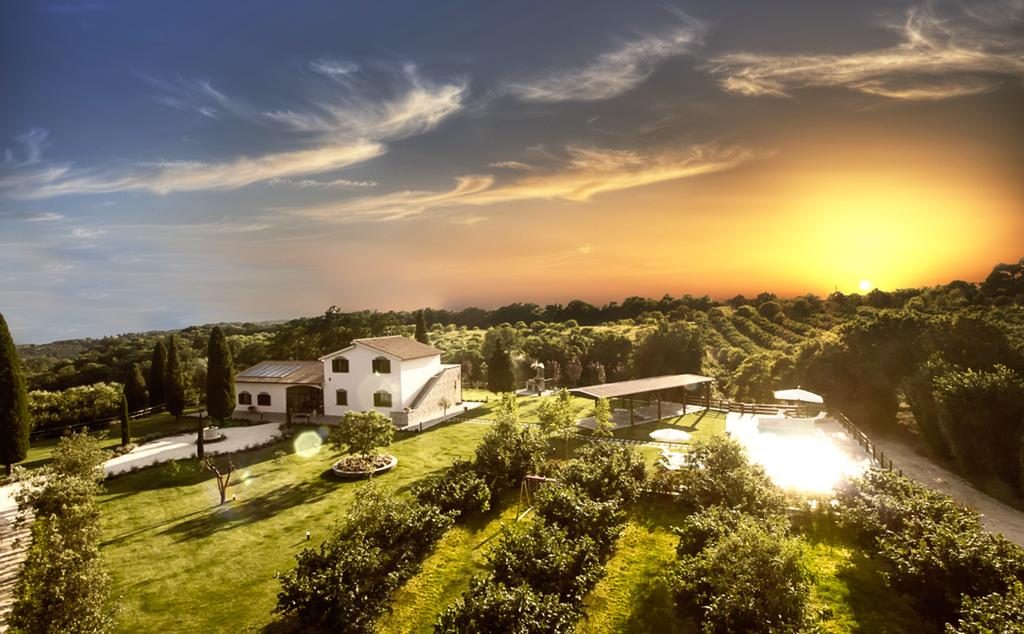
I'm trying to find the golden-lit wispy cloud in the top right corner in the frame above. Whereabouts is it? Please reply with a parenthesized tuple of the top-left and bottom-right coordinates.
(708, 0, 1024, 100)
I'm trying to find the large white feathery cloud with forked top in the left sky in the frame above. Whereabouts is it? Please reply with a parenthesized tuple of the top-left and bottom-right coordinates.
(0, 61, 466, 200)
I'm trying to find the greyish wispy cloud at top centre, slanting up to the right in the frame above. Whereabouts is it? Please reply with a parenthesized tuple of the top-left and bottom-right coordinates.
(507, 14, 706, 101)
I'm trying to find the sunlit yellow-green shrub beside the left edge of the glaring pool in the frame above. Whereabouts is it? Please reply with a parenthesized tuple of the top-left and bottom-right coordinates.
(663, 436, 784, 517)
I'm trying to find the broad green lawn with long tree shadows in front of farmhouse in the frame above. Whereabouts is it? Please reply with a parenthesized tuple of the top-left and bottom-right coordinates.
(100, 423, 487, 632)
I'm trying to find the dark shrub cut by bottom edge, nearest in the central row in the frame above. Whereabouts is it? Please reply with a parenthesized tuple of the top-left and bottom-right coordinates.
(434, 579, 579, 634)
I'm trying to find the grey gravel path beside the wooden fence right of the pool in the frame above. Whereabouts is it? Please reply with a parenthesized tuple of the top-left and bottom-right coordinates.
(871, 436, 1024, 546)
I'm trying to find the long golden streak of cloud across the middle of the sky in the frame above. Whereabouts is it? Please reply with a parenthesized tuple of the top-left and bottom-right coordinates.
(280, 144, 759, 222)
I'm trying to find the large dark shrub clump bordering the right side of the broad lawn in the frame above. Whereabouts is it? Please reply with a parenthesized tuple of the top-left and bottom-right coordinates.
(275, 485, 452, 633)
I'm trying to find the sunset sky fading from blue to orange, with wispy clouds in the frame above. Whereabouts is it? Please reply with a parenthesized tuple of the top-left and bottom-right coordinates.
(0, 0, 1024, 342)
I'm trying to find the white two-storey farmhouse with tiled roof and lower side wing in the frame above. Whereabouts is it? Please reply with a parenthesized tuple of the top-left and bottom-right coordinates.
(234, 336, 462, 428)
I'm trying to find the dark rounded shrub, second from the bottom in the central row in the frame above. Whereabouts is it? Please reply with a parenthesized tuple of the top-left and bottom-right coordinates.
(487, 521, 601, 604)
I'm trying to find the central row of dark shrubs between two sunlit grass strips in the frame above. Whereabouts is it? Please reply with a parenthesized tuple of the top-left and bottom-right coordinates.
(435, 443, 645, 634)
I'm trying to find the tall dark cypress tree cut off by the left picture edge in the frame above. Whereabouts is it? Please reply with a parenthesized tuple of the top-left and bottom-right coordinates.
(0, 314, 29, 475)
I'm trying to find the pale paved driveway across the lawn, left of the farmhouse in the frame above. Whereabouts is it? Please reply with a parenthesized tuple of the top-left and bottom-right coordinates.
(103, 423, 281, 474)
